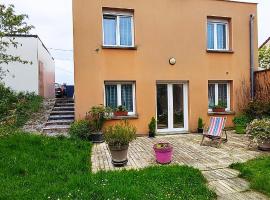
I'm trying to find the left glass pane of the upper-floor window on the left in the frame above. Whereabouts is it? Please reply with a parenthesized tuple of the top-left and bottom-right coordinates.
(103, 15, 116, 45)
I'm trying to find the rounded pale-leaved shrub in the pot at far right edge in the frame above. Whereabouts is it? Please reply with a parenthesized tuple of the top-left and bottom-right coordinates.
(246, 118, 270, 141)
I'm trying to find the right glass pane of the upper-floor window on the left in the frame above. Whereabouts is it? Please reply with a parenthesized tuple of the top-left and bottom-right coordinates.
(120, 16, 132, 46)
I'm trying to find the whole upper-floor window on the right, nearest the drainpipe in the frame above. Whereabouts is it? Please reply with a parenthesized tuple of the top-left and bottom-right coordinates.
(207, 19, 229, 51)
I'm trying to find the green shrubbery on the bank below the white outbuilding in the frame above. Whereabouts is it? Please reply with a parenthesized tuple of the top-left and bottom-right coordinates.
(0, 84, 42, 127)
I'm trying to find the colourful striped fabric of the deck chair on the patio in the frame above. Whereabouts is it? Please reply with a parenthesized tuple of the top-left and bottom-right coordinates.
(207, 117, 226, 137)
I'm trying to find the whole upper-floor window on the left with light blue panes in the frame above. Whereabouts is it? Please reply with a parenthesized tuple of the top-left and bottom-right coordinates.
(103, 12, 134, 47)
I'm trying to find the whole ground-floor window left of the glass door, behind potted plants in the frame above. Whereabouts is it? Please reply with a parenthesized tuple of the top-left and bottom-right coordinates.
(105, 82, 135, 115)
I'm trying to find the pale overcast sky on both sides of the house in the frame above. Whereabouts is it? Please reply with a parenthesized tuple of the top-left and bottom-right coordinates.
(0, 0, 270, 84)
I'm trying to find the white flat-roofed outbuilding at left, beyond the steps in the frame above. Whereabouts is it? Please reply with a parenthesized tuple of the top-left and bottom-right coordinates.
(1, 36, 55, 98)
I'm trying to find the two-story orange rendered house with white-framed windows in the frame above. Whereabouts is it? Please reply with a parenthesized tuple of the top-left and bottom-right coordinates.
(73, 0, 257, 134)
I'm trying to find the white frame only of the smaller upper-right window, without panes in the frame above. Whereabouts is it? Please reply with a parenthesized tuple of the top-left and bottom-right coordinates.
(207, 19, 230, 51)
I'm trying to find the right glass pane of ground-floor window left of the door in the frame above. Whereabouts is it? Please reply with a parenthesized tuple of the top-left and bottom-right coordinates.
(121, 84, 133, 112)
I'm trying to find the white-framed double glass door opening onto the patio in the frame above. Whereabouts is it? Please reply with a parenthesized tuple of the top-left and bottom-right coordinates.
(157, 83, 188, 133)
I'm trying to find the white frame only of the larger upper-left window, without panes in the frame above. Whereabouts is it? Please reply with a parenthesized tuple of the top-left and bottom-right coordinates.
(102, 11, 134, 47)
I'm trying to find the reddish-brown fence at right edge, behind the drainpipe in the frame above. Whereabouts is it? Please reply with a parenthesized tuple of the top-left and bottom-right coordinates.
(255, 69, 270, 101)
